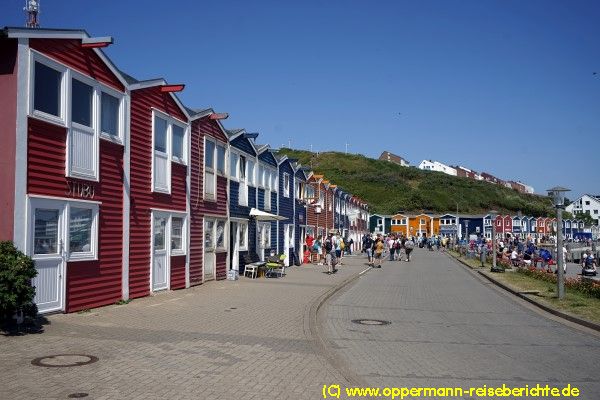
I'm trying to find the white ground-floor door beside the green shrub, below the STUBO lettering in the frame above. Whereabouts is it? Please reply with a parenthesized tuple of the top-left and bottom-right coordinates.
(29, 199, 66, 313)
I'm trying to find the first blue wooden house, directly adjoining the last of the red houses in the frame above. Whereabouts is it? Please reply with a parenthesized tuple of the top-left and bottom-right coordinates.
(227, 129, 258, 273)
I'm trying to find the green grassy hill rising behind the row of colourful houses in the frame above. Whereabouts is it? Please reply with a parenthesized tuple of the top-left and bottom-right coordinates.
(279, 148, 552, 216)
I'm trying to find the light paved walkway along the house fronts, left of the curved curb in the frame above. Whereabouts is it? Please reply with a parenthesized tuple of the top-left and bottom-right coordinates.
(0, 258, 364, 400)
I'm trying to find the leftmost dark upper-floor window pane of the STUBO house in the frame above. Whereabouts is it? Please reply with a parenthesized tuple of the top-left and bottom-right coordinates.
(33, 62, 61, 117)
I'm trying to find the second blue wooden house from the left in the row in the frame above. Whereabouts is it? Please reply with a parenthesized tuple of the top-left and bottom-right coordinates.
(255, 145, 279, 260)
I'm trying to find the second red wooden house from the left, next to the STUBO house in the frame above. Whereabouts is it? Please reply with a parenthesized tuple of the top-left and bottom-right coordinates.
(128, 77, 189, 298)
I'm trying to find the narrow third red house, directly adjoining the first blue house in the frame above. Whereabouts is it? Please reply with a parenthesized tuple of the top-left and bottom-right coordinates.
(190, 109, 229, 285)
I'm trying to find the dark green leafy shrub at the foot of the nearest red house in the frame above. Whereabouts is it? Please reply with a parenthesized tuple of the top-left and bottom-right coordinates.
(0, 242, 37, 324)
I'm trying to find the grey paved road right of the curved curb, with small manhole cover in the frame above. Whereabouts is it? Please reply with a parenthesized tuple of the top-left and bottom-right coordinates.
(321, 249, 600, 400)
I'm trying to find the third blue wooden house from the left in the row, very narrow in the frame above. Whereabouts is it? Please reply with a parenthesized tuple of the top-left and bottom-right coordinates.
(277, 155, 297, 266)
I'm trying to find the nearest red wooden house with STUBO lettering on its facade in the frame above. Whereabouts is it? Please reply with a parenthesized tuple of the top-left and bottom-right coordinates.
(0, 28, 128, 312)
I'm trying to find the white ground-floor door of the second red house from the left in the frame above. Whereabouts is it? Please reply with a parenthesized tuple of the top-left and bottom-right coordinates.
(152, 212, 170, 292)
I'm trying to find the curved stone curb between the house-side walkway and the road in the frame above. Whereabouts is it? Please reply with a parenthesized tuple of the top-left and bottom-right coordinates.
(304, 268, 371, 386)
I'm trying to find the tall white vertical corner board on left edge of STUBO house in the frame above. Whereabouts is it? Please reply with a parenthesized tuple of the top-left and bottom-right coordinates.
(13, 38, 31, 252)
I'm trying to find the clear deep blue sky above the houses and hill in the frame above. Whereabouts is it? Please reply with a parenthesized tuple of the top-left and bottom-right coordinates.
(0, 0, 600, 197)
